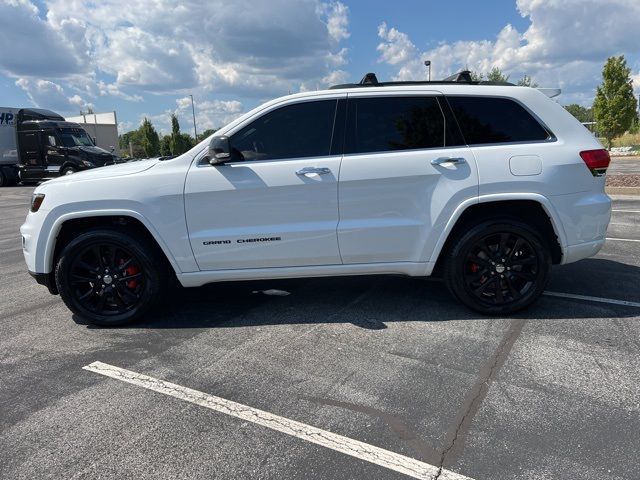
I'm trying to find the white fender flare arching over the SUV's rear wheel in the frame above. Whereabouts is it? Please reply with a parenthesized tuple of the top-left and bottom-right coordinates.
(429, 193, 567, 268)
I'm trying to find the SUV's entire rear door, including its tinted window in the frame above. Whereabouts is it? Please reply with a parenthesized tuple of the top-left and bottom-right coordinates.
(338, 93, 478, 264)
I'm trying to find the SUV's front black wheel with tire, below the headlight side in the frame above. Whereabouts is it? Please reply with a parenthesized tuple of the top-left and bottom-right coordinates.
(55, 228, 169, 326)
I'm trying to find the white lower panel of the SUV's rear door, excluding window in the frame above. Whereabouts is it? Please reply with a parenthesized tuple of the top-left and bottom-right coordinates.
(338, 147, 478, 264)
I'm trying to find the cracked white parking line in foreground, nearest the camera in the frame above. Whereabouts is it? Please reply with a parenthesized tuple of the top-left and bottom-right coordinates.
(82, 362, 472, 480)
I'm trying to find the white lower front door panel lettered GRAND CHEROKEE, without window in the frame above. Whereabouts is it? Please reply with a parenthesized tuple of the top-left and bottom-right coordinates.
(185, 156, 341, 270)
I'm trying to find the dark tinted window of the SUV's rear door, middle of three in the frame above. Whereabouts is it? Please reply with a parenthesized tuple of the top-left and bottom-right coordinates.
(346, 97, 444, 153)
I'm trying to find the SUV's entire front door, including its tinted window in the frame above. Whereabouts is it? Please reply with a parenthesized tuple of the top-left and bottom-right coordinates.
(185, 95, 346, 270)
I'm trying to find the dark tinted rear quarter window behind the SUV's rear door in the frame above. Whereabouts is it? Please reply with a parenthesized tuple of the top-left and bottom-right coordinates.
(447, 97, 549, 145)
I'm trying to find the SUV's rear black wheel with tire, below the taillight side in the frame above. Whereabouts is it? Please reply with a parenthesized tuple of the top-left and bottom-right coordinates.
(443, 217, 551, 315)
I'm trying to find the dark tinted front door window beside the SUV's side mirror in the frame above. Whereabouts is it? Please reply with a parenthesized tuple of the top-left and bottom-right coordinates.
(231, 100, 336, 160)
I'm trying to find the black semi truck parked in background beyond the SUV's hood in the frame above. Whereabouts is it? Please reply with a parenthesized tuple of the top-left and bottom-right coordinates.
(0, 107, 123, 186)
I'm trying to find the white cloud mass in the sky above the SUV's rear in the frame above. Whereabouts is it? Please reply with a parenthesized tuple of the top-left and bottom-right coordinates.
(378, 0, 640, 103)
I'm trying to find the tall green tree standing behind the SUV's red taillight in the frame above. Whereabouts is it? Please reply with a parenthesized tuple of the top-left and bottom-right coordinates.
(593, 55, 638, 148)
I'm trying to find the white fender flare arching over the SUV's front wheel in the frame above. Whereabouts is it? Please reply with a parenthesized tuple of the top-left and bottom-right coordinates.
(36, 209, 182, 274)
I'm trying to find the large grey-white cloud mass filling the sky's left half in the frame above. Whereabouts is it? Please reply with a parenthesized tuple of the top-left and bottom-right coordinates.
(0, 0, 349, 100)
